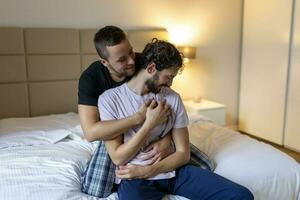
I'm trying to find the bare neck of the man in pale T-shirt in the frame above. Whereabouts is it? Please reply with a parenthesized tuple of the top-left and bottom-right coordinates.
(127, 72, 149, 95)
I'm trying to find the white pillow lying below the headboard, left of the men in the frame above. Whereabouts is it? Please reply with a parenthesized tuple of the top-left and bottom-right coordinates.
(0, 113, 83, 149)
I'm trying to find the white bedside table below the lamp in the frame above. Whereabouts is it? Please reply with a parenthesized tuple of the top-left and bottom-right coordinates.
(183, 99, 225, 126)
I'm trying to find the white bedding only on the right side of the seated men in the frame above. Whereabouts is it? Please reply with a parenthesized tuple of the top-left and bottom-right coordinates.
(189, 122, 300, 200)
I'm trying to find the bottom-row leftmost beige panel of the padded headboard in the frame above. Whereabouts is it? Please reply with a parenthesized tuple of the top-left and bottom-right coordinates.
(0, 83, 29, 118)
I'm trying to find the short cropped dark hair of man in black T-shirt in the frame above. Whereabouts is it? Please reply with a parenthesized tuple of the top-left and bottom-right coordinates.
(94, 26, 126, 59)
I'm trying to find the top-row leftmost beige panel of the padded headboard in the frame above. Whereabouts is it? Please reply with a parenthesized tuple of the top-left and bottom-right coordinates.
(0, 28, 24, 54)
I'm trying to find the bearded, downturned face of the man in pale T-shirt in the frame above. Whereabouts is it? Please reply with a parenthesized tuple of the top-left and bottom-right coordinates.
(146, 67, 178, 93)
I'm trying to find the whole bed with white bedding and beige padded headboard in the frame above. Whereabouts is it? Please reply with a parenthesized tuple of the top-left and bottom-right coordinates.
(0, 27, 300, 200)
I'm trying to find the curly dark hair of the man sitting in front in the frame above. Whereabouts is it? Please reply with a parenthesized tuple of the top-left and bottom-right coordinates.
(140, 38, 183, 71)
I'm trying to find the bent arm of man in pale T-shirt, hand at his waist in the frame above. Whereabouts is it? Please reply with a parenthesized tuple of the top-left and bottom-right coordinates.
(116, 127, 190, 179)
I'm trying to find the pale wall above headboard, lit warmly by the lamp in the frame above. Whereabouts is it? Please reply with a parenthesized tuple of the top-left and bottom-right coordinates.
(0, 0, 242, 125)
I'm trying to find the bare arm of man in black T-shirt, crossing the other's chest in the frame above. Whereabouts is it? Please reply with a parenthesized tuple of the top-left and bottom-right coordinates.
(78, 102, 148, 142)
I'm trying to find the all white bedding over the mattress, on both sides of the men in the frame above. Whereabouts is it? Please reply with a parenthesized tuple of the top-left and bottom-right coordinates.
(0, 113, 300, 200)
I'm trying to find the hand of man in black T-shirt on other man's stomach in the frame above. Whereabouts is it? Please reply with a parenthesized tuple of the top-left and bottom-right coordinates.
(138, 131, 174, 165)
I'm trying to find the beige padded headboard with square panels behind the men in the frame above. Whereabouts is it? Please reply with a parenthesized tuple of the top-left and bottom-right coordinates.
(0, 27, 168, 118)
